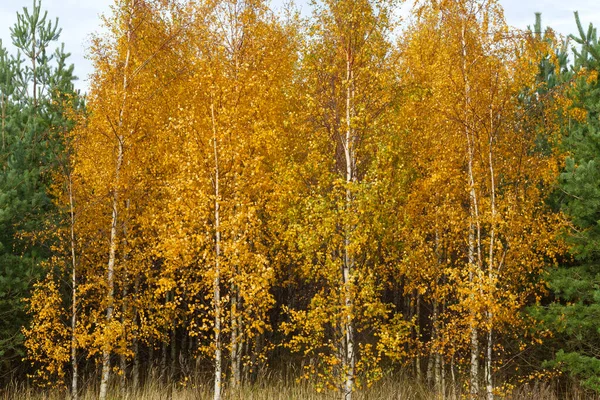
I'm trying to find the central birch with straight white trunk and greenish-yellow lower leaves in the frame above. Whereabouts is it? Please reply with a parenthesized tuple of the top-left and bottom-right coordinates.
(285, 1, 404, 399)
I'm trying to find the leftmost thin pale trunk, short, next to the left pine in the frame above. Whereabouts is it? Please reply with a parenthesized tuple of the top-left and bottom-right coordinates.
(68, 174, 79, 400)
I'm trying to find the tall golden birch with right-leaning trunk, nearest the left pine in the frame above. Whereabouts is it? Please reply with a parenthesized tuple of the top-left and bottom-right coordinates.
(75, 0, 186, 399)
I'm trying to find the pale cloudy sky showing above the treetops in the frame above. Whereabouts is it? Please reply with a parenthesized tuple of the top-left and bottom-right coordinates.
(0, 0, 600, 92)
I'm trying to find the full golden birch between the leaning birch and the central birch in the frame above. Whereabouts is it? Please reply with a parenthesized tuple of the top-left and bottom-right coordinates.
(151, 1, 295, 399)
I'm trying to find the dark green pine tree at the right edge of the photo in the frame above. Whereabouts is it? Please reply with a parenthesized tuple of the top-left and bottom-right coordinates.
(533, 13, 600, 392)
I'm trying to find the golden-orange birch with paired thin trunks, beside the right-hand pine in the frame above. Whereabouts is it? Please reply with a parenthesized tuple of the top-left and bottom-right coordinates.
(400, 1, 561, 399)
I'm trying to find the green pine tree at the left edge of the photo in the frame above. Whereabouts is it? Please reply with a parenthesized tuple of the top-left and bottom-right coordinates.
(0, 1, 76, 372)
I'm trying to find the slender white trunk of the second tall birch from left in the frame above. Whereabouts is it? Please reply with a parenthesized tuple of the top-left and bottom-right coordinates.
(210, 101, 223, 400)
